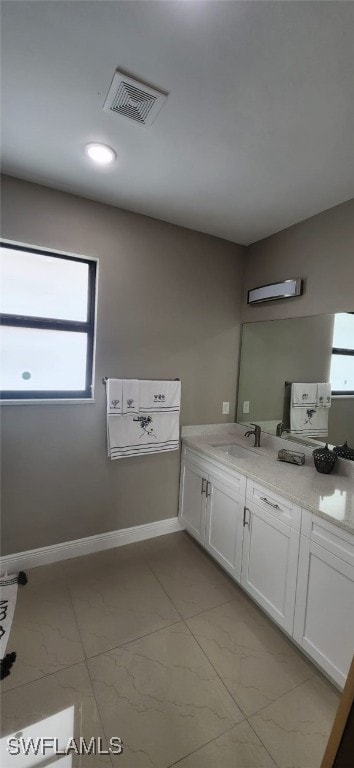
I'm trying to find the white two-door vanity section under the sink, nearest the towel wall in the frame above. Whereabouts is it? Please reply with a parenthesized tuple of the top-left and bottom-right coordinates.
(180, 450, 246, 581)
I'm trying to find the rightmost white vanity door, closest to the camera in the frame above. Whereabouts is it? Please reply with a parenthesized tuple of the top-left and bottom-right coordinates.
(294, 536, 354, 687)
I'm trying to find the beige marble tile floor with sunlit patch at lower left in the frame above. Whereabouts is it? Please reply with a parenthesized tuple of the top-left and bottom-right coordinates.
(1, 532, 340, 768)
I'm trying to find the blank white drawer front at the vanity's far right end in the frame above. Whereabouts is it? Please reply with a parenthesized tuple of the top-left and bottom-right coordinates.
(301, 509, 354, 566)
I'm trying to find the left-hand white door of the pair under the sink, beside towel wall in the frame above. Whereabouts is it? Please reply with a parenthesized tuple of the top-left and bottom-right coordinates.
(180, 461, 208, 545)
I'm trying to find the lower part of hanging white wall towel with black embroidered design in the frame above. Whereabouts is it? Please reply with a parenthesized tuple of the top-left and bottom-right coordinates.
(107, 412, 179, 459)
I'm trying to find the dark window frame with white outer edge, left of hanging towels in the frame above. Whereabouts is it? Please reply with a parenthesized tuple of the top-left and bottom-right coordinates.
(0, 238, 98, 405)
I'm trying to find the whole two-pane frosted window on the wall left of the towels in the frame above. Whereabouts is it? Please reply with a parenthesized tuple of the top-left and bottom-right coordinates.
(0, 242, 96, 400)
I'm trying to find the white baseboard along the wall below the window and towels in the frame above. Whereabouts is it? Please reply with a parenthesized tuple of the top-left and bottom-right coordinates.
(0, 517, 183, 574)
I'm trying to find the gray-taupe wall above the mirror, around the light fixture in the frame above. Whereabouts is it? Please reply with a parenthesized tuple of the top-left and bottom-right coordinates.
(242, 200, 354, 323)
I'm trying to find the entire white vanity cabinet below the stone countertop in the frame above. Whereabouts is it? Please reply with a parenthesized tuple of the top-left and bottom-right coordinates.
(179, 446, 354, 687)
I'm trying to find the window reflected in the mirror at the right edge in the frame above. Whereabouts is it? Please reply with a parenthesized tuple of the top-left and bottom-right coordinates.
(330, 312, 354, 395)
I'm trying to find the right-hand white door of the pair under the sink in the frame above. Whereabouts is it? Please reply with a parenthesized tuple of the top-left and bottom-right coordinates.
(205, 475, 244, 581)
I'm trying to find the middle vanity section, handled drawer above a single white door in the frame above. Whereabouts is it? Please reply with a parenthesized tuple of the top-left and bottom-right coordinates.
(241, 480, 301, 634)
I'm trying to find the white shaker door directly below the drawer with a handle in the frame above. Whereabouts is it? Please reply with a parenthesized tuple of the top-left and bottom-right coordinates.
(241, 504, 299, 634)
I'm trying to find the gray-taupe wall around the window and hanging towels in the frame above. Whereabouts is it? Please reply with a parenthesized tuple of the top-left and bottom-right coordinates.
(2, 177, 245, 554)
